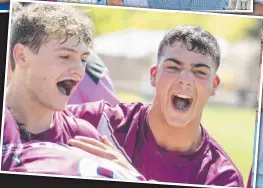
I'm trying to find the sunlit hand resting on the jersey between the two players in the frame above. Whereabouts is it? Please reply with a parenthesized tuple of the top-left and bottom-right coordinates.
(68, 136, 138, 173)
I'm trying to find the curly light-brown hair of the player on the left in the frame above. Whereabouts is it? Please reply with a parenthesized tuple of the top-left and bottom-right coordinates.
(9, 3, 93, 71)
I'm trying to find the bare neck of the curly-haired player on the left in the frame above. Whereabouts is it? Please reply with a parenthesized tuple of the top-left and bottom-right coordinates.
(6, 82, 53, 134)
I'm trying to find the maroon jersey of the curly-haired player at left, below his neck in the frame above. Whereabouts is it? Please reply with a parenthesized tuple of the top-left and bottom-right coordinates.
(2, 106, 101, 170)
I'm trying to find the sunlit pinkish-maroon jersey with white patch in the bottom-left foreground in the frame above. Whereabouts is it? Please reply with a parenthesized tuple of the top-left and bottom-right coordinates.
(1, 107, 145, 180)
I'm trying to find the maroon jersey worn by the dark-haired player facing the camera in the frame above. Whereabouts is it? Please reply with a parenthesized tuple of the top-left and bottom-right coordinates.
(67, 101, 244, 187)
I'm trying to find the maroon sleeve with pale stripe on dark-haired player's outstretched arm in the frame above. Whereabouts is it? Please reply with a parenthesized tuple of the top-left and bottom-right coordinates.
(67, 101, 143, 163)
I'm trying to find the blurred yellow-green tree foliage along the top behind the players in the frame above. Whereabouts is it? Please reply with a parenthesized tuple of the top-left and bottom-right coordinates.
(76, 7, 261, 41)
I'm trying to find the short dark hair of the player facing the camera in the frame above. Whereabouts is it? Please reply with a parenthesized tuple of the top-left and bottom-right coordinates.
(158, 25, 220, 69)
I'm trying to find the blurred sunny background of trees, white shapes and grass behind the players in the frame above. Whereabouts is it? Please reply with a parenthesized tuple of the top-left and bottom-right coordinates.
(77, 7, 261, 187)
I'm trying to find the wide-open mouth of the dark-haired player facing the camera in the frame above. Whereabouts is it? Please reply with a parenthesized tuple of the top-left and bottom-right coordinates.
(172, 94, 193, 112)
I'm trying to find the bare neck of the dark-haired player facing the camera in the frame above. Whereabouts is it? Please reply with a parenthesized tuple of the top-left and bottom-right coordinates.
(148, 105, 202, 152)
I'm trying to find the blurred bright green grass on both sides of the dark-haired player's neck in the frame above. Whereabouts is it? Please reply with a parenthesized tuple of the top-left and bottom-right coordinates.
(117, 92, 256, 185)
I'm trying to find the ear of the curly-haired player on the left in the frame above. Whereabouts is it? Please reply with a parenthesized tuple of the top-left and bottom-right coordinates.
(13, 44, 27, 69)
